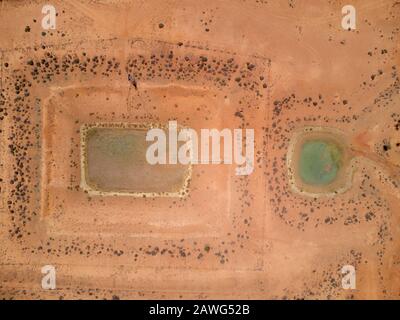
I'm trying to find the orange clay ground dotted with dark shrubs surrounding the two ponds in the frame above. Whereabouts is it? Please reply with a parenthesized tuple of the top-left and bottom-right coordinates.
(0, 0, 400, 299)
